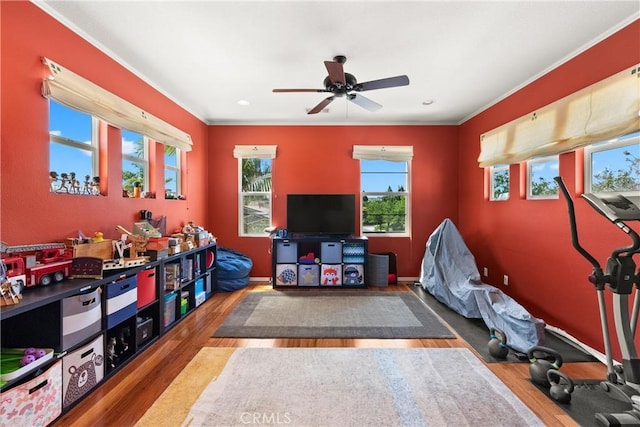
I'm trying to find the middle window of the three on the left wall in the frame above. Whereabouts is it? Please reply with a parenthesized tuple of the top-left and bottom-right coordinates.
(122, 129, 149, 197)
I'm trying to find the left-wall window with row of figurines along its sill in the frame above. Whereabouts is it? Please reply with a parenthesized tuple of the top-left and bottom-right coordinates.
(49, 99, 100, 195)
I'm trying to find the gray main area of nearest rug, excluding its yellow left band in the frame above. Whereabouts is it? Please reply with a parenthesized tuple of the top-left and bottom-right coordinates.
(183, 348, 543, 427)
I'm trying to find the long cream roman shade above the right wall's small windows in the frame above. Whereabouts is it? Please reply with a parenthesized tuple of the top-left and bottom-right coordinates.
(478, 64, 640, 167)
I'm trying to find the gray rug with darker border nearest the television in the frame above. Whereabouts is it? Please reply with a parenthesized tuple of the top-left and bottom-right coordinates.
(213, 290, 455, 338)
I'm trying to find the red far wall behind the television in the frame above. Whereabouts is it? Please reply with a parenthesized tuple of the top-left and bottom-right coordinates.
(208, 126, 458, 277)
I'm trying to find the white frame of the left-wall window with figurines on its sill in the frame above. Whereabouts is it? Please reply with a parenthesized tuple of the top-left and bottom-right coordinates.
(49, 98, 101, 196)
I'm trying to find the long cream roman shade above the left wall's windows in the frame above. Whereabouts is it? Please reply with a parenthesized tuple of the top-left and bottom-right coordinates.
(42, 58, 193, 151)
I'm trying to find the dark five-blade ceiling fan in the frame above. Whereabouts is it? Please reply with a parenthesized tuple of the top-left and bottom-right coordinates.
(273, 55, 409, 114)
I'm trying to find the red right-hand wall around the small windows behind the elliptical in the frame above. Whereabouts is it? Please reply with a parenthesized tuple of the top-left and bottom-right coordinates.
(458, 21, 640, 362)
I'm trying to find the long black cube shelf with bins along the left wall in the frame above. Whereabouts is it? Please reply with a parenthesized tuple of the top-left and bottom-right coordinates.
(0, 242, 217, 425)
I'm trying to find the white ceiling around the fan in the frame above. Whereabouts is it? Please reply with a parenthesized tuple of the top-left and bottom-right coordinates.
(35, 0, 640, 124)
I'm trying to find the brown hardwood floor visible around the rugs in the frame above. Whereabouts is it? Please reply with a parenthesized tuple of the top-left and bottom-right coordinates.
(55, 284, 606, 427)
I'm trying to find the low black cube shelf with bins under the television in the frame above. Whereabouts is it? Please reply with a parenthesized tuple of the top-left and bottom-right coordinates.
(272, 236, 368, 288)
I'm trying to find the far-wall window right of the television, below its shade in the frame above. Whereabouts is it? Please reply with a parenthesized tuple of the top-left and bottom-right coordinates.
(360, 159, 409, 235)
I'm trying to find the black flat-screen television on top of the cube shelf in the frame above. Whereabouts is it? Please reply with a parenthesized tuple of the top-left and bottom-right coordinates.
(287, 194, 356, 235)
